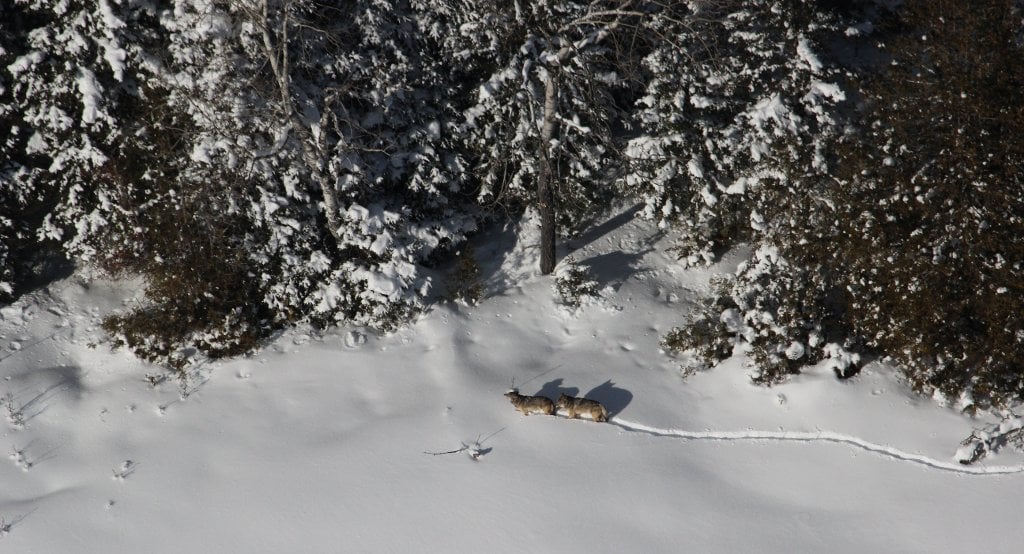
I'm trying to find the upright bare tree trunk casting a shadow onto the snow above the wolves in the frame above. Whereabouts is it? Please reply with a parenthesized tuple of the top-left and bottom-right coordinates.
(537, 68, 558, 274)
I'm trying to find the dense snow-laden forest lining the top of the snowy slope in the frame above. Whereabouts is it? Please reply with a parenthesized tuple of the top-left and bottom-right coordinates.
(6, 0, 1024, 410)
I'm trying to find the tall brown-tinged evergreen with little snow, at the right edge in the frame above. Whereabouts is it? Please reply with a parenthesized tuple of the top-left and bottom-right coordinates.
(825, 0, 1024, 410)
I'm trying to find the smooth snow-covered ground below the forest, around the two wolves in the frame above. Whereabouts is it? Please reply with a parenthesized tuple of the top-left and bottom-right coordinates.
(0, 204, 1024, 554)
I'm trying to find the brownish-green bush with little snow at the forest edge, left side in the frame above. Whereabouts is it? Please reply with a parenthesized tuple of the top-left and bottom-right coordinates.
(101, 176, 273, 371)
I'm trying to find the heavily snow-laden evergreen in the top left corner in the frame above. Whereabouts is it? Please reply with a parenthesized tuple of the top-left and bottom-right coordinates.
(5, 0, 153, 259)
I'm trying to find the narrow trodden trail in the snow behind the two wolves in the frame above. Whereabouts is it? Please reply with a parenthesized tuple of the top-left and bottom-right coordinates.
(608, 418, 1024, 475)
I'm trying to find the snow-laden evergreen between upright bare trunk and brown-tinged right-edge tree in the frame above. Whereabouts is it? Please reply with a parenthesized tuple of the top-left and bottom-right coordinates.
(627, 0, 846, 263)
